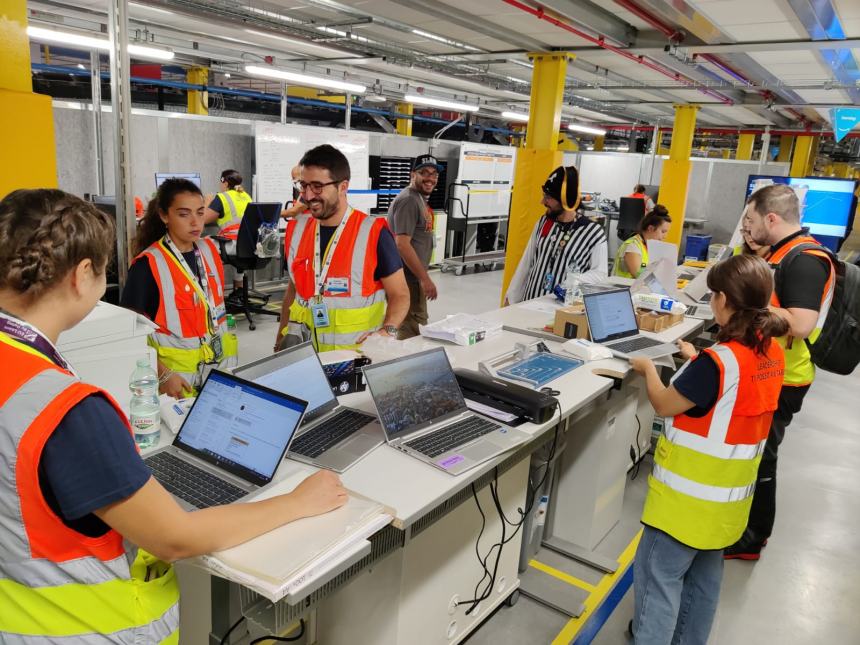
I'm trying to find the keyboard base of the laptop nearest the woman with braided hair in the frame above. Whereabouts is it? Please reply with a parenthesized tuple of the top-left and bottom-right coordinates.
(144, 452, 248, 508)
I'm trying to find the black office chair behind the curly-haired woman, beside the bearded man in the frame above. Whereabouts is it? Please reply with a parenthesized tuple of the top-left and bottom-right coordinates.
(213, 202, 281, 330)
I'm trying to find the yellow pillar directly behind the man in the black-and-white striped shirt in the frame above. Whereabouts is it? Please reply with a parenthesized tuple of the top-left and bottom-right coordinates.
(502, 52, 574, 295)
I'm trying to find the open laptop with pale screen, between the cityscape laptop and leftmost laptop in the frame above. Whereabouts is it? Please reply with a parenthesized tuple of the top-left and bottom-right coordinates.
(233, 343, 384, 473)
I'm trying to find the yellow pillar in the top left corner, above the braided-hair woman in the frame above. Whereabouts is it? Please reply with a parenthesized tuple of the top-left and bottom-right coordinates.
(0, 0, 57, 198)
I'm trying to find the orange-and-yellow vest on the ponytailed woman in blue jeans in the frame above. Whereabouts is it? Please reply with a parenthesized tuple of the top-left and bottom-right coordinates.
(642, 341, 785, 549)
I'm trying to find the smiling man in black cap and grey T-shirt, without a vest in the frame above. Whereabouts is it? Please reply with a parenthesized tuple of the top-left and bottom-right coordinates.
(388, 155, 442, 339)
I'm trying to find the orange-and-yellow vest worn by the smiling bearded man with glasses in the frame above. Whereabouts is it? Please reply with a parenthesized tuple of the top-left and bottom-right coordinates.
(284, 210, 388, 352)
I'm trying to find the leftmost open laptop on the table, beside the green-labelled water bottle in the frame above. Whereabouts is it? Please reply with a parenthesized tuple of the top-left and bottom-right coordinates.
(144, 370, 307, 510)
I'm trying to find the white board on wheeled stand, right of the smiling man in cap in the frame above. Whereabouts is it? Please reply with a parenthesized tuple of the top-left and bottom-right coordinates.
(450, 142, 517, 218)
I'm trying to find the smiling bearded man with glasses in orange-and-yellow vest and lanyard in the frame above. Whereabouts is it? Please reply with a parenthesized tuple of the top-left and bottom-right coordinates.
(275, 144, 409, 352)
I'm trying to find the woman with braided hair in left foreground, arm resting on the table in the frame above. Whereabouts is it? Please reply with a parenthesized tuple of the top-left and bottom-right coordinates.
(0, 190, 346, 645)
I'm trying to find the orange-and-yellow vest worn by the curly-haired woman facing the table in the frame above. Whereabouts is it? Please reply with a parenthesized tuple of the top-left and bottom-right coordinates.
(135, 238, 238, 385)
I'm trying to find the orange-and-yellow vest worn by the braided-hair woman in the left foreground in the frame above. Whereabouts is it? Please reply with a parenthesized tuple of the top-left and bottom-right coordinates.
(0, 333, 179, 645)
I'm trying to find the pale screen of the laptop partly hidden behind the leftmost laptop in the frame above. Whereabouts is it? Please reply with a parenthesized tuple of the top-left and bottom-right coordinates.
(233, 343, 337, 423)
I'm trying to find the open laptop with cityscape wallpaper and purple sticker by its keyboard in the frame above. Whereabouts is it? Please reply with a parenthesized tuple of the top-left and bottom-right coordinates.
(364, 347, 529, 475)
